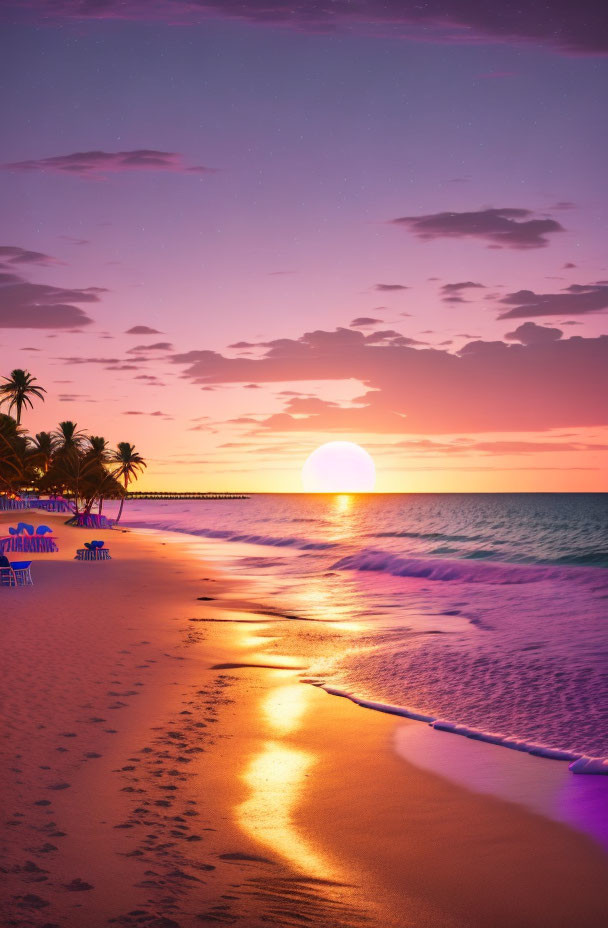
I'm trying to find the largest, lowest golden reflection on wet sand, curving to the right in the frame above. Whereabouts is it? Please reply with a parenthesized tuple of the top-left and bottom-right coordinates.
(236, 740, 339, 880)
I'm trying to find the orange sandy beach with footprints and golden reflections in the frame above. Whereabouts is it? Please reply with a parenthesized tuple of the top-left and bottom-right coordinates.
(0, 513, 608, 928)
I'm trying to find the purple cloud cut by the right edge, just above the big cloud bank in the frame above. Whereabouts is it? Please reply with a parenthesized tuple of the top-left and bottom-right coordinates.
(498, 282, 608, 319)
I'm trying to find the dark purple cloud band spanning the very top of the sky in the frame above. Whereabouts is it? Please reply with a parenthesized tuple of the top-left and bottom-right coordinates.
(2, 0, 608, 54)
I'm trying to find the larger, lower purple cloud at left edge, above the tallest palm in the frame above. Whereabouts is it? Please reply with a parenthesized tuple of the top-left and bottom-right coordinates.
(0, 274, 101, 330)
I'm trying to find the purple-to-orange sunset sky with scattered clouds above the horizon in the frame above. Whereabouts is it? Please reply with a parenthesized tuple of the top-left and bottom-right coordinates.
(0, 0, 608, 491)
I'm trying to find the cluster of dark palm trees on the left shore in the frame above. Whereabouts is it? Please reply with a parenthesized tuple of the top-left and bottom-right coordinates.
(0, 370, 146, 520)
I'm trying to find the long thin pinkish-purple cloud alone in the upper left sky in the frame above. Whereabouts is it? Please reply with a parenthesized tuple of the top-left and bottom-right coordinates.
(3, 148, 211, 177)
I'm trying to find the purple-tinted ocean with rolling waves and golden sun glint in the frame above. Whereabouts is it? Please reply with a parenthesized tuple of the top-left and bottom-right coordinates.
(123, 493, 608, 772)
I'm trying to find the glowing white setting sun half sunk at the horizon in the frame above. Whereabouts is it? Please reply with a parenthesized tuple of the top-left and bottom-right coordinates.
(302, 441, 376, 493)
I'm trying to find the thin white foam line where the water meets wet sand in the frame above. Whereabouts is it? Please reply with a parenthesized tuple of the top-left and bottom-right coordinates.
(309, 681, 608, 775)
